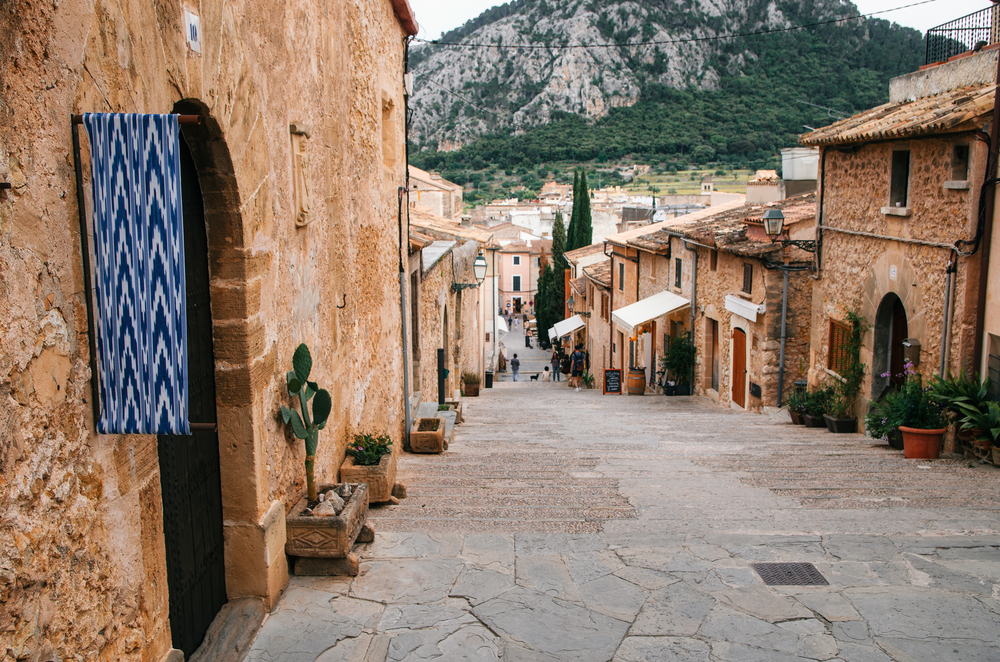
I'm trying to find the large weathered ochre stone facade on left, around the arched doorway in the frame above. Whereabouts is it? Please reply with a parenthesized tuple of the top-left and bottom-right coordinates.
(0, 0, 416, 662)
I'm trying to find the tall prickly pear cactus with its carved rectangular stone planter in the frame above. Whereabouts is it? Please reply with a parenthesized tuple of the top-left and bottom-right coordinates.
(281, 343, 368, 575)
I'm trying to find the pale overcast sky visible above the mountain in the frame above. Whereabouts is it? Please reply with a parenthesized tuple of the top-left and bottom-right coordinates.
(410, 0, 992, 39)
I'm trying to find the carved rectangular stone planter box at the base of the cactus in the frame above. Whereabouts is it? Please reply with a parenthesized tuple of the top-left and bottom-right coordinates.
(285, 483, 368, 559)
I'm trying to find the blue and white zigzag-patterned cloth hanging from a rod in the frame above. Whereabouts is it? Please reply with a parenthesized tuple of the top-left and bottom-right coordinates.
(83, 114, 191, 434)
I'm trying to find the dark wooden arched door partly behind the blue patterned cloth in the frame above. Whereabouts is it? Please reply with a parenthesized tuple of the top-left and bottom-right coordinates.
(157, 138, 226, 657)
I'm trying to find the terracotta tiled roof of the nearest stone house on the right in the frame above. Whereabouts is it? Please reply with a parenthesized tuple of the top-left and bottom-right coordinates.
(799, 85, 996, 145)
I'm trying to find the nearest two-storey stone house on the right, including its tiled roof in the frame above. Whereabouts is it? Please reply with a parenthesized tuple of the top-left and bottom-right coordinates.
(801, 50, 997, 416)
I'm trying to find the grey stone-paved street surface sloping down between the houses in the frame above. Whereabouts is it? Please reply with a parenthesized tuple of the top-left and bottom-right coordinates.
(248, 382, 1000, 662)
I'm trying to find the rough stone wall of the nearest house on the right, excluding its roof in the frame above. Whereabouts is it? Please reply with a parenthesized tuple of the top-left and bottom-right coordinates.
(809, 135, 986, 413)
